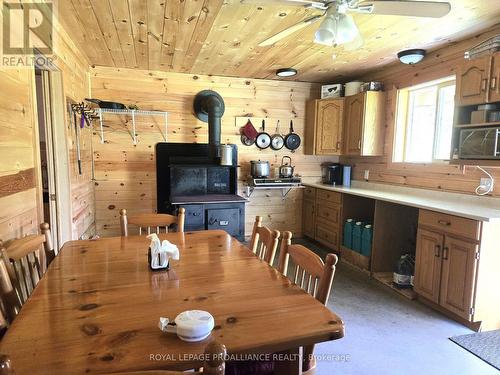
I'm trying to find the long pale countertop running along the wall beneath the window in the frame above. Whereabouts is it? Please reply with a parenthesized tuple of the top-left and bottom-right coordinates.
(302, 181, 500, 221)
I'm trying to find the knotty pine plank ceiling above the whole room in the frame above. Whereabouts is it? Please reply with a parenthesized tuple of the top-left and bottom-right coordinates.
(59, 0, 500, 82)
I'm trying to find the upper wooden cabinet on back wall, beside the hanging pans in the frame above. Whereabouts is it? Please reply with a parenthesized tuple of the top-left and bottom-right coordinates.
(305, 98, 344, 155)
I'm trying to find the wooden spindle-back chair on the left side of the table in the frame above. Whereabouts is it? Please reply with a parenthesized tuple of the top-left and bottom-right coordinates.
(0, 223, 56, 304)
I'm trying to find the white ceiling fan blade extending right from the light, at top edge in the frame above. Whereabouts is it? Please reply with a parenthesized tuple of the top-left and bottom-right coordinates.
(355, 0, 451, 18)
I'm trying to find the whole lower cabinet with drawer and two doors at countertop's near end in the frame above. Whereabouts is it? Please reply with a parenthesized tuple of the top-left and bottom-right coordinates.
(414, 210, 479, 321)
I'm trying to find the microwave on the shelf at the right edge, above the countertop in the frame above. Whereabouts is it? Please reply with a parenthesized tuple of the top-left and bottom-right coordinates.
(458, 127, 500, 159)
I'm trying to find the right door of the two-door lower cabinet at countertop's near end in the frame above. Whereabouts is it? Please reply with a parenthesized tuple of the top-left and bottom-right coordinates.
(439, 236, 478, 320)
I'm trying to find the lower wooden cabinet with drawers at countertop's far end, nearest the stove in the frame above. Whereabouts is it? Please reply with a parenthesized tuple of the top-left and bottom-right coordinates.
(302, 187, 342, 251)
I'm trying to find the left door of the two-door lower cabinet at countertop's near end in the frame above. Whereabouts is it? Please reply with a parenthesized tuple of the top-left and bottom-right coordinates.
(414, 229, 444, 303)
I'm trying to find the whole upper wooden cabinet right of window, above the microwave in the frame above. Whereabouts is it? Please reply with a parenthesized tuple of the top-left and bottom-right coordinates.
(456, 52, 500, 105)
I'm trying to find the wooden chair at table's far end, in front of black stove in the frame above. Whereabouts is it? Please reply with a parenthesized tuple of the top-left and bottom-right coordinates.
(120, 207, 186, 237)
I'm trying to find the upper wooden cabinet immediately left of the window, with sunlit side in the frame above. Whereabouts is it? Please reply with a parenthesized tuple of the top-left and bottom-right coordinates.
(344, 91, 385, 156)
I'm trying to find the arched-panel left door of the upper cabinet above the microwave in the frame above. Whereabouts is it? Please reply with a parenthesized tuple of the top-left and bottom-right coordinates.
(456, 56, 490, 105)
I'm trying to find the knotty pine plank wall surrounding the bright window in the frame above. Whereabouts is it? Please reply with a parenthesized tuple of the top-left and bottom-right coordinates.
(341, 25, 500, 196)
